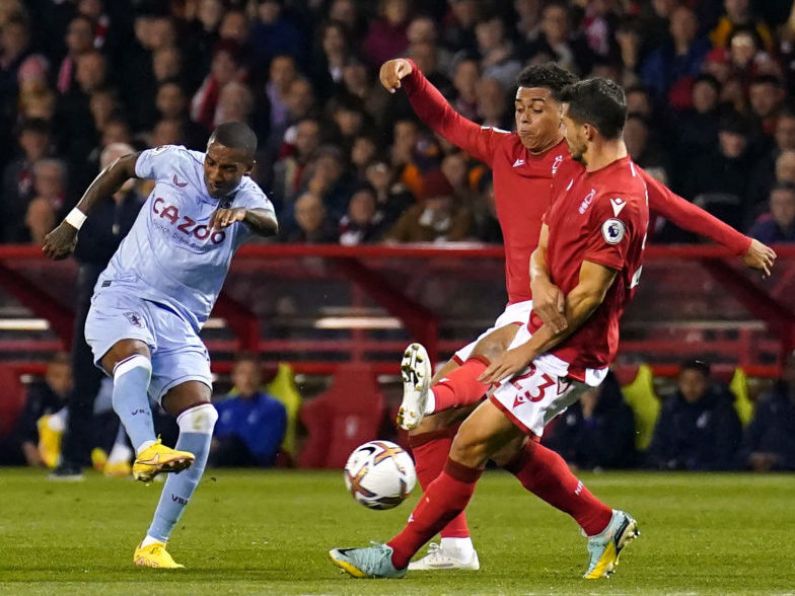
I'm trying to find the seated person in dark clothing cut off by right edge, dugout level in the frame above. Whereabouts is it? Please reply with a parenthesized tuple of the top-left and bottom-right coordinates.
(741, 352, 795, 472)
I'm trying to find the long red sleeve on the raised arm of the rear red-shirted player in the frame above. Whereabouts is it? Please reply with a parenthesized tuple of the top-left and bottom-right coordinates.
(402, 60, 510, 167)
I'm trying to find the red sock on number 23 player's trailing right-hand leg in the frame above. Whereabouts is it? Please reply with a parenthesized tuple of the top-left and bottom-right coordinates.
(505, 441, 613, 536)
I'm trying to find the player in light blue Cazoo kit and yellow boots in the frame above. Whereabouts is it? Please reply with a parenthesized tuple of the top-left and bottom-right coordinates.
(43, 122, 278, 568)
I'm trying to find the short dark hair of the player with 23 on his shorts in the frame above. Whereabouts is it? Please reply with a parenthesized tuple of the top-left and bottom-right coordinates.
(559, 77, 627, 139)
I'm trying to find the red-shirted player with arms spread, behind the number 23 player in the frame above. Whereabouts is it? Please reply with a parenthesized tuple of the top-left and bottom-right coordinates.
(381, 59, 775, 570)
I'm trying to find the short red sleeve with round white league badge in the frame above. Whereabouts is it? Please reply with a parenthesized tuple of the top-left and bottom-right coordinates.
(583, 194, 638, 271)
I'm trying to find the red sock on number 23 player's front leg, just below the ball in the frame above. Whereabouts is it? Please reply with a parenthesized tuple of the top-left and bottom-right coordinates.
(387, 459, 483, 569)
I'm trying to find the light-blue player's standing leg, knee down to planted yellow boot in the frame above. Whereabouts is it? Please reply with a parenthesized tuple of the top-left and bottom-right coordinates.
(133, 380, 218, 569)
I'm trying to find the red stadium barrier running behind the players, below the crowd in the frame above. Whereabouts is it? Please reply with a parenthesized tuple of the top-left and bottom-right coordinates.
(0, 245, 795, 376)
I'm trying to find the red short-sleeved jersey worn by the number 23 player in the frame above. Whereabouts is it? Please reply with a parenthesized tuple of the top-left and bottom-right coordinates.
(530, 157, 649, 378)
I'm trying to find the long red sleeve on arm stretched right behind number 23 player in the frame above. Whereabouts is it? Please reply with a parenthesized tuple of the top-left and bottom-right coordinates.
(635, 165, 751, 255)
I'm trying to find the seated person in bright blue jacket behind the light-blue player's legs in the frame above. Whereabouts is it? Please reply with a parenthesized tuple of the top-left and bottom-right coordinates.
(209, 355, 287, 467)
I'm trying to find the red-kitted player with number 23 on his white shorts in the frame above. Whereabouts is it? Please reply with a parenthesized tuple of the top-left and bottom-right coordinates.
(330, 79, 649, 579)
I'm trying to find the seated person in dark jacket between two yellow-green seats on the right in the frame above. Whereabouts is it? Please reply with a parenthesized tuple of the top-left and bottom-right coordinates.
(648, 360, 742, 471)
